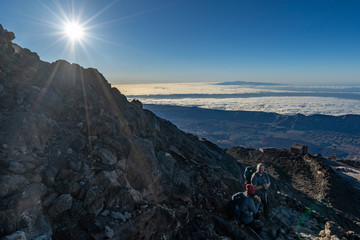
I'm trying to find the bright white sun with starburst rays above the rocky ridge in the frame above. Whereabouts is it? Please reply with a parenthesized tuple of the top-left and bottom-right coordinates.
(39, 0, 115, 62)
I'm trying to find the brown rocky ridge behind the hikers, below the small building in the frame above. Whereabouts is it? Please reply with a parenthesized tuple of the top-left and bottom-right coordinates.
(227, 147, 360, 226)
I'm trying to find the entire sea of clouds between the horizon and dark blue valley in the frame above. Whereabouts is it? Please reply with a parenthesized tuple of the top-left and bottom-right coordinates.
(115, 83, 360, 116)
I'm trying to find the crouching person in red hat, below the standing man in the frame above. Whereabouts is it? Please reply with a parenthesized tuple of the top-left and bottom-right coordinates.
(239, 184, 261, 230)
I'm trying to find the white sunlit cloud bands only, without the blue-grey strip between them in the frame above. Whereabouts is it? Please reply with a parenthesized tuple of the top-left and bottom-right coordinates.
(116, 83, 360, 116)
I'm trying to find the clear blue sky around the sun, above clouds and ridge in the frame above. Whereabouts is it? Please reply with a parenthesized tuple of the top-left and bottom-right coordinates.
(0, 0, 360, 85)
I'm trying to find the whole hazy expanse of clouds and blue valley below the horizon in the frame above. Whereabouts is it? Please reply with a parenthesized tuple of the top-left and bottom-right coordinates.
(116, 82, 360, 160)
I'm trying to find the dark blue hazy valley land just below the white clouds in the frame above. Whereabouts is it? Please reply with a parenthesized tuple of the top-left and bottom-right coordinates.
(144, 104, 360, 160)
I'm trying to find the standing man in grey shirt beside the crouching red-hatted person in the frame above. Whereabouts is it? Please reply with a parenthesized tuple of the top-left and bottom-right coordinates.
(251, 163, 270, 219)
